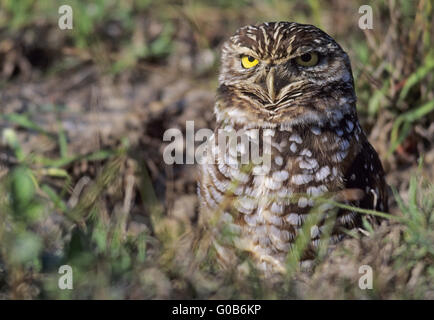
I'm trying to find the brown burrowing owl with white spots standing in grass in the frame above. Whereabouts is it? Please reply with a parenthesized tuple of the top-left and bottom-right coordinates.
(198, 22, 387, 272)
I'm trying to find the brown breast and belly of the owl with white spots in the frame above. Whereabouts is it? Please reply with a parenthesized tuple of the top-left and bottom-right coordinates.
(199, 112, 384, 270)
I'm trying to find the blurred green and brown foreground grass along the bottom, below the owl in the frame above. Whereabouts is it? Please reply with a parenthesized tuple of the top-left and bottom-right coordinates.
(0, 119, 434, 299)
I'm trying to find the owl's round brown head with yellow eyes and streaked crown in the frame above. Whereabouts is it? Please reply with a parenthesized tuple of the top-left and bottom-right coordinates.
(216, 22, 356, 126)
